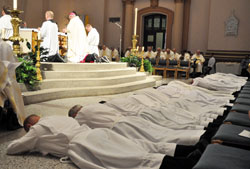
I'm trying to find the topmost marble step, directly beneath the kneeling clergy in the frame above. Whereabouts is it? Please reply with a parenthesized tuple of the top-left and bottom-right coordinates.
(41, 62, 127, 71)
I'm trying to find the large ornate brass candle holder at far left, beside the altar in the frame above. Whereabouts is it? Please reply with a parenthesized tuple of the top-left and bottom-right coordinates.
(7, 9, 23, 56)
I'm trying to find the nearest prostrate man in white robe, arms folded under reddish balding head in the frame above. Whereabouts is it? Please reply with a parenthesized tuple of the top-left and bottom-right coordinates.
(7, 115, 172, 169)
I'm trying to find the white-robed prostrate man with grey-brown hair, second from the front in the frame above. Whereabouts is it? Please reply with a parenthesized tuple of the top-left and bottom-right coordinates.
(69, 104, 205, 146)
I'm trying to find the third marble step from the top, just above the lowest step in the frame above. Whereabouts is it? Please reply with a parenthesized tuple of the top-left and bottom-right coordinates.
(39, 72, 146, 90)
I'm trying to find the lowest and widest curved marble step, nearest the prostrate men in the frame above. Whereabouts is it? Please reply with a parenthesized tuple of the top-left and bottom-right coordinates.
(22, 77, 156, 105)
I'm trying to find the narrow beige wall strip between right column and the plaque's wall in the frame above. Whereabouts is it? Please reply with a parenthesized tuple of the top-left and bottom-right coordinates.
(188, 0, 210, 52)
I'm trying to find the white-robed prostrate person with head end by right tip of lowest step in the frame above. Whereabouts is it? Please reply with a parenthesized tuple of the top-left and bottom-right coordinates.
(157, 80, 234, 107)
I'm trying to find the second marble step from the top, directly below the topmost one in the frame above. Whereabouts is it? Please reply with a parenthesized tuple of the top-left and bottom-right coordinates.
(42, 67, 136, 79)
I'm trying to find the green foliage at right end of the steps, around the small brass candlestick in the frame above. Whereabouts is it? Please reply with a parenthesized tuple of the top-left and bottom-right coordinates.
(121, 55, 153, 73)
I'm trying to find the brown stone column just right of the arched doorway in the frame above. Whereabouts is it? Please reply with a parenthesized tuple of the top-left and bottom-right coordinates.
(172, 0, 184, 52)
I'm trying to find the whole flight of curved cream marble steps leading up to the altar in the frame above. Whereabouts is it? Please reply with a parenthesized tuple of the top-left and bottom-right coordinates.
(22, 62, 158, 105)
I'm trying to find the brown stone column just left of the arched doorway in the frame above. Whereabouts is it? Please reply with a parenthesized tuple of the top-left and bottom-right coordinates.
(123, 0, 135, 50)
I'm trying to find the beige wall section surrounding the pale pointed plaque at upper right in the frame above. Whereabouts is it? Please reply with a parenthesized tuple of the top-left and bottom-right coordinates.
(208, 0, 250, 51)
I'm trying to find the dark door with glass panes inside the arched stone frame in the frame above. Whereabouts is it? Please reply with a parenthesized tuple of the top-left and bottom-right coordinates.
(143, 14, 167, 50)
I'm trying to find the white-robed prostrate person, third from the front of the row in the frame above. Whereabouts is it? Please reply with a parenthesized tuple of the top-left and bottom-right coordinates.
(105, 94, 224, 129)
